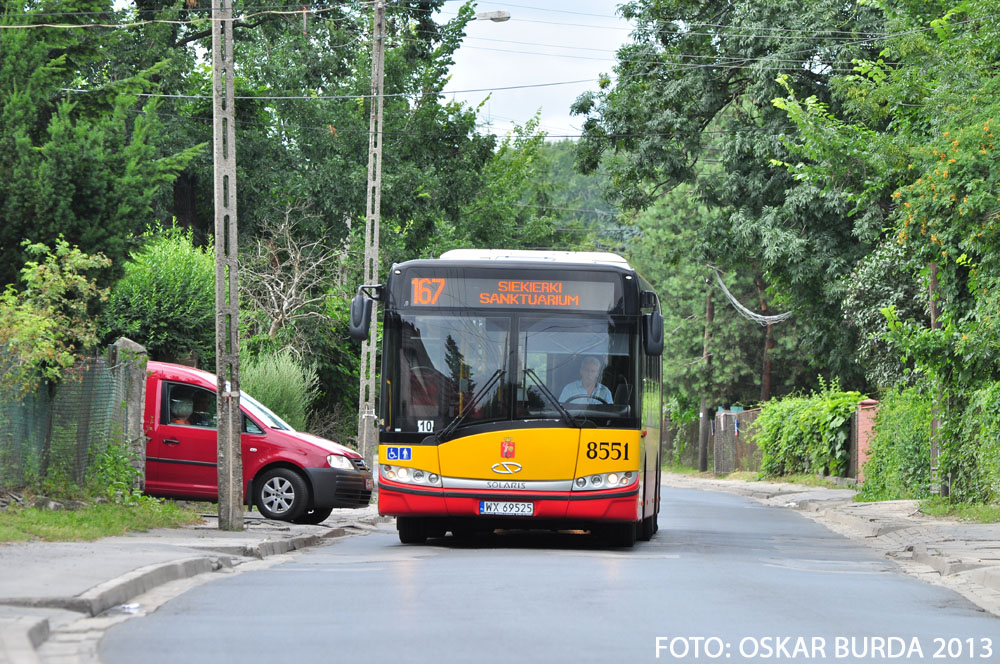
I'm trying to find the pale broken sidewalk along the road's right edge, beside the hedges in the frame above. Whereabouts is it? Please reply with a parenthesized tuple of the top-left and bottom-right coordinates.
(660, 473, 1000, 617)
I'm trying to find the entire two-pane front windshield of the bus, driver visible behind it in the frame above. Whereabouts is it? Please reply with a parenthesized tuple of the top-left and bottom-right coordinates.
(383, 311, 636, 434)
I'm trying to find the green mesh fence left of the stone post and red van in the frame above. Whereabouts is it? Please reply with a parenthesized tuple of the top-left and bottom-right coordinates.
(0, 357, 128, 488)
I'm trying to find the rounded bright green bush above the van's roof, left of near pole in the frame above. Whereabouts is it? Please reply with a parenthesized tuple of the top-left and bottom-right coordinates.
(101, 226, 215, 366)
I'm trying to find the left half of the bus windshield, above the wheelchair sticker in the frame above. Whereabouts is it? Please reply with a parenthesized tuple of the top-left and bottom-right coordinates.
(389, 315, 510, 434)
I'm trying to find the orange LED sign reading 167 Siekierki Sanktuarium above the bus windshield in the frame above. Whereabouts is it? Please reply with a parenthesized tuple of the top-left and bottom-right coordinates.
(410, 277, 617, 311)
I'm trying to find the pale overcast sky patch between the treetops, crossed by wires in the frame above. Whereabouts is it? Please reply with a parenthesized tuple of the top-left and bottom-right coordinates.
(441, 0, 630, 138)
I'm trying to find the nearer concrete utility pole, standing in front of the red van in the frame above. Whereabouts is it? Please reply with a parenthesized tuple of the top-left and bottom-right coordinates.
(212, 0, 243, 530)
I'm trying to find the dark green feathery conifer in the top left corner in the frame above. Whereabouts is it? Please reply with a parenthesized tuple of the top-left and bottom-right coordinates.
(0, 0, 201, 283)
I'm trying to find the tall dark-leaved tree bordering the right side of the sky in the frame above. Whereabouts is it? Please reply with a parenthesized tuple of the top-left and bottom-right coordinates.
(573, 0, 883, 390)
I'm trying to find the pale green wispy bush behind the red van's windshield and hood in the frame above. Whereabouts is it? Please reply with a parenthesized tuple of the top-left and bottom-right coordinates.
(240, 351, 319, 430)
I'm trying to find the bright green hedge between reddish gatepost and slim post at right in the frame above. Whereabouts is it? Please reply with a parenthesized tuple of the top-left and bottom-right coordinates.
(858, 387, 932, 500)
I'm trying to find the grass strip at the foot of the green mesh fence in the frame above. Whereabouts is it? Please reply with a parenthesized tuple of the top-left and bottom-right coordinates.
(0, 498, 201, 542)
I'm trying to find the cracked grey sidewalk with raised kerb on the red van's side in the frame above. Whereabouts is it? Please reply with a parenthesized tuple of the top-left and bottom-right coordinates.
(0, 505, 386, 664)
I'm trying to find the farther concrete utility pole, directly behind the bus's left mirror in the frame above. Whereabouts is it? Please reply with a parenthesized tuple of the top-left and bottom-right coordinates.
(358, 2, 385, 468)
